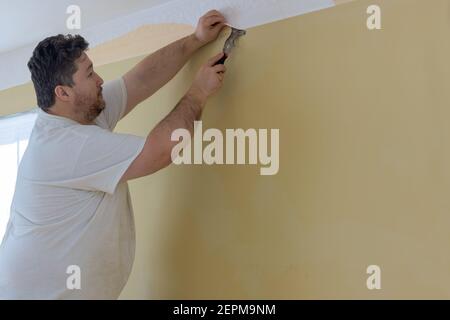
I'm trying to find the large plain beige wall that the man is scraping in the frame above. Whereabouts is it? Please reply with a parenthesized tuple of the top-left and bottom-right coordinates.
(0, 0, 450, 299)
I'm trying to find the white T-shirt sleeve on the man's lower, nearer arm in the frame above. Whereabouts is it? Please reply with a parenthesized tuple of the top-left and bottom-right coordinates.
(51, 126, 146, 194)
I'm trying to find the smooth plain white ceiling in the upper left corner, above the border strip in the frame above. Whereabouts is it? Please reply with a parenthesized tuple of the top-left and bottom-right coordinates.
(0, 0, 170, 53)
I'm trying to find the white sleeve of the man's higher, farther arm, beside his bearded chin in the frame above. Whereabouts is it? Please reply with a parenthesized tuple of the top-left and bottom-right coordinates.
(95, 78, 128, 131)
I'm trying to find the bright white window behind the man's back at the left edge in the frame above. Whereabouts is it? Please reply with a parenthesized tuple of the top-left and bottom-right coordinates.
(0, 110, 37, 241)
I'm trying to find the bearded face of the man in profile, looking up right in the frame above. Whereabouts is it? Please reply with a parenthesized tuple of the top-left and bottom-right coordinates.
(72, 53, 105, 122)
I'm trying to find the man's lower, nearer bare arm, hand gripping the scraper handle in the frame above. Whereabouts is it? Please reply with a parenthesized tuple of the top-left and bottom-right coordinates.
(120, 53, 226, 182)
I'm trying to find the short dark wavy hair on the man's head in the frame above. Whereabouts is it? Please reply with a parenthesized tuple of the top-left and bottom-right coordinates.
(28, 34, 89, 111)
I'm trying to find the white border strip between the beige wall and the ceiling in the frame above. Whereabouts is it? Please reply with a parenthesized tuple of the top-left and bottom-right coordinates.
(0, 0, 335, 90)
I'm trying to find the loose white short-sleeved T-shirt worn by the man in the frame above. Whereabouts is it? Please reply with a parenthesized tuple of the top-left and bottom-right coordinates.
(0, 78, 145, 299)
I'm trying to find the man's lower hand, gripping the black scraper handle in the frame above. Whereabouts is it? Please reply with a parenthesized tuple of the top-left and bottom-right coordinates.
(188, 53, 226, 107)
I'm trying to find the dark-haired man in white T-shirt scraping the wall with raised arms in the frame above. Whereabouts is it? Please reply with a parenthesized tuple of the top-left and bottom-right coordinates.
(0, 10, 225, 299)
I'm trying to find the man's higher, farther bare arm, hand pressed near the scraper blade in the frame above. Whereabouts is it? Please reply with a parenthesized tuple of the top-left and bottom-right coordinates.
(123, 10, 225, 116)
